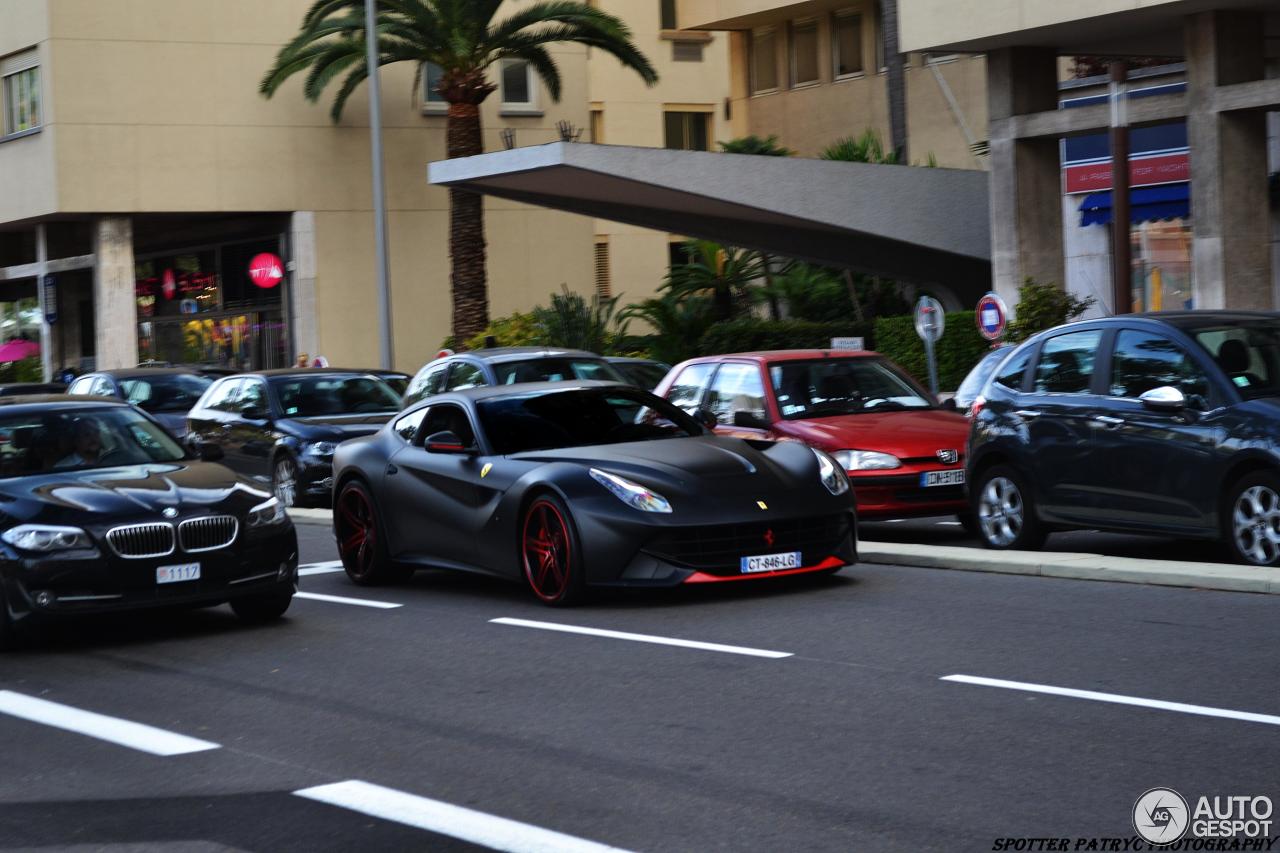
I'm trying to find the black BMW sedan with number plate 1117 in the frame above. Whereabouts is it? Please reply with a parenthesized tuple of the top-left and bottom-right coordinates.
(0, 397, 298, 646)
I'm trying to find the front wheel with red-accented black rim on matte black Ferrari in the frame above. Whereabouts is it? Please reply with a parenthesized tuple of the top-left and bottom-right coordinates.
(520, 494, 586, 607)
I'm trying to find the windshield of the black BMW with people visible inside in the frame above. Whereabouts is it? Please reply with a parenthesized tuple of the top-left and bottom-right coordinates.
(0, 406, 186, 478)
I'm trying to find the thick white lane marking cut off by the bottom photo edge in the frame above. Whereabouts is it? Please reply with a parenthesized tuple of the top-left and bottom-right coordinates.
(293, 779, 625, 853)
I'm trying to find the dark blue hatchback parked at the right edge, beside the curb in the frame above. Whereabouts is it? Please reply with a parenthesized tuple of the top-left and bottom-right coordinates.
(968, 311, 1280, 566)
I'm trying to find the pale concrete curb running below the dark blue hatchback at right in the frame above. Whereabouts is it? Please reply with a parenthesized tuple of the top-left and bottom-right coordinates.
(858, 542, 1280, 596)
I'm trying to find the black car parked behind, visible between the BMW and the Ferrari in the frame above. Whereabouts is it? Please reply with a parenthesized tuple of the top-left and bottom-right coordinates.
(188, 368, 401, 506)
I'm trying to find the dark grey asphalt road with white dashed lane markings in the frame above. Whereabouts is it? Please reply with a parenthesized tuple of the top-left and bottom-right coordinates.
(0, 525, 1280, 853)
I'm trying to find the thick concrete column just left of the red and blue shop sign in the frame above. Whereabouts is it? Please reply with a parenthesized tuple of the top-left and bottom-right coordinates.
(987, 47, 1065, 305)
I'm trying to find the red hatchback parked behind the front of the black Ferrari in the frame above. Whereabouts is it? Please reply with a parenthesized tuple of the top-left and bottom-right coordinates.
(654, 350, 969, 521)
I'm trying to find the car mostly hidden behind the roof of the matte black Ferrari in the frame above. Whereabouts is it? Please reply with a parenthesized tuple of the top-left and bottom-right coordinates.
(404, 347, 631, 409)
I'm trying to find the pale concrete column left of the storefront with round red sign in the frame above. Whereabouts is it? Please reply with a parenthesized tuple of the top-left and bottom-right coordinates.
(93, 216, 138, 370)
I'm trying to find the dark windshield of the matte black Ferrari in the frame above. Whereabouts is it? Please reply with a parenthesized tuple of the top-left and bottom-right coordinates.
(476, 388, 703, 456)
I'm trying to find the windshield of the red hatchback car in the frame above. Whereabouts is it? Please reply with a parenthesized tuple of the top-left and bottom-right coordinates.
(769, 359, 933, 420)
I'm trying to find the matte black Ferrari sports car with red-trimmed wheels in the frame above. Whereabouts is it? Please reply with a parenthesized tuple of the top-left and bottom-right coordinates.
(334, 382, 856, 605)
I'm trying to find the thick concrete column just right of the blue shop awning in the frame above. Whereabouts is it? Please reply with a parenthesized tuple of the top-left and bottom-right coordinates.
(1185, 12, 1275, 310)
